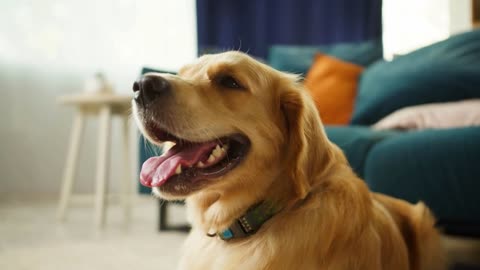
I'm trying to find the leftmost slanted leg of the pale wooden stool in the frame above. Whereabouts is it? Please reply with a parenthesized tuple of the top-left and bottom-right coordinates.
(57, 110, 85, 221)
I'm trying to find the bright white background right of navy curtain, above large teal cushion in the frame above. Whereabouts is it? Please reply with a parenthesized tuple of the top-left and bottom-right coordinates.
(382, 0, 472, 60)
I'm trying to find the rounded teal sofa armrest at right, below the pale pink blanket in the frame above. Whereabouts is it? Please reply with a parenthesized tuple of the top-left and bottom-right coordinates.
(365, 127, 480, 222)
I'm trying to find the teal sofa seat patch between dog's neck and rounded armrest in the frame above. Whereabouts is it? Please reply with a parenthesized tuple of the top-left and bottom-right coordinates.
(325, 126, 398, 177)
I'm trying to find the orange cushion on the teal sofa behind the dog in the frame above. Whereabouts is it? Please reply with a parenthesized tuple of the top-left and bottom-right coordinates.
(305, 53, 363, 125)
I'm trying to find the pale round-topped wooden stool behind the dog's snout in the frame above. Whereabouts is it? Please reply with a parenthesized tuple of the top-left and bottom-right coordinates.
(57, 94, 134, 229)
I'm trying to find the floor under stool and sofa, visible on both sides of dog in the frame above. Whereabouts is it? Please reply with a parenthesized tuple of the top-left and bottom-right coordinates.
(0, 196, 480, 270)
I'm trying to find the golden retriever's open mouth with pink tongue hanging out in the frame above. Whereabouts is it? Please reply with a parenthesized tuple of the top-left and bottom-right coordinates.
(140, 125, 250, 187)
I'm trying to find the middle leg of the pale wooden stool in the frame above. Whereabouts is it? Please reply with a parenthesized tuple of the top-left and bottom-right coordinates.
(95, 106, 112, 229)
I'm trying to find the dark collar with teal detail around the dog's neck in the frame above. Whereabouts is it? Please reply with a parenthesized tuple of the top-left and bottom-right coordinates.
(207, 202, 279, 241)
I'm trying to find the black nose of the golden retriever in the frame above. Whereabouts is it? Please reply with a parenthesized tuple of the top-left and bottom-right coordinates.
(133, 75, 171, 102)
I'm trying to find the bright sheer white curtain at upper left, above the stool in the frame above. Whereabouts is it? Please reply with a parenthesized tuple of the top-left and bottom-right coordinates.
(0, 0, 196, 72)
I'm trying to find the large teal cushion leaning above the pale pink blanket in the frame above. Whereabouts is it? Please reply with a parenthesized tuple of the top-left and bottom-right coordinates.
(351, 30, 480, 125)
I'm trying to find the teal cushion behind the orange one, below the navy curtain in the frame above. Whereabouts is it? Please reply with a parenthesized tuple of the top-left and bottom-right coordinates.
(268, 40, 383, 74)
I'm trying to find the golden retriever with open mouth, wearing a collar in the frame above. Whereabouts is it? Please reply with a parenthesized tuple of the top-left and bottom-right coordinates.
(132, 52, 444, 270)
